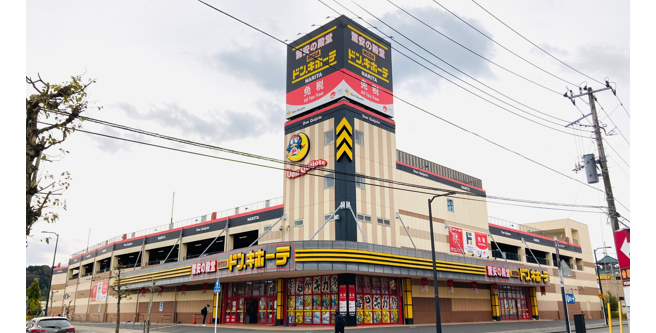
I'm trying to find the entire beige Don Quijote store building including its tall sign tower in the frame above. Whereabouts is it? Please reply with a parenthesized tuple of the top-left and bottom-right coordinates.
(51, 16, 602, 326)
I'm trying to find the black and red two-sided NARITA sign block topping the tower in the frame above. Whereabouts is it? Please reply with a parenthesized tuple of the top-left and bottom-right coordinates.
(286, 16, 394, 118)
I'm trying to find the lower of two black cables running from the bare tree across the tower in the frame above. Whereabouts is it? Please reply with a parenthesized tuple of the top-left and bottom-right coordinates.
(39, 122, 603, 217)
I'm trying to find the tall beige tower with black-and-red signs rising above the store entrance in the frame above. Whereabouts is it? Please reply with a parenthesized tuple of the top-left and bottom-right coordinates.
(283, 16, 396, 243)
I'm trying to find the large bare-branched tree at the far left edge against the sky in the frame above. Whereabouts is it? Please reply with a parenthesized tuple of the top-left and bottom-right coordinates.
(25, 76, 102, 241)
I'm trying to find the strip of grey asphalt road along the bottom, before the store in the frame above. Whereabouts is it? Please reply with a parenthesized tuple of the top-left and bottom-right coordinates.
(73, 320, 629, 333)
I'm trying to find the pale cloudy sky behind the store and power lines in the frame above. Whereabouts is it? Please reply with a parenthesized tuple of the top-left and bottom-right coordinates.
(25, 0, 631, 265)
